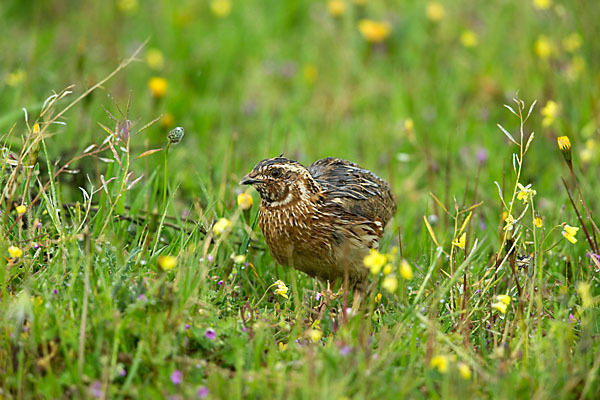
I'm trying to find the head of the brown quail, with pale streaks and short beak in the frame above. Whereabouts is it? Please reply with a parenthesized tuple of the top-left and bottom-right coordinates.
(240, 157, 321, 207)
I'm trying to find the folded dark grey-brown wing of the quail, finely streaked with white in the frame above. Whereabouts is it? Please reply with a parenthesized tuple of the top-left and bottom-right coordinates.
(308, 157, 396, 225)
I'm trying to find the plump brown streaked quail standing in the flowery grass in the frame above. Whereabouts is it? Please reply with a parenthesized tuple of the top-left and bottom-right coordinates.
(240, 155, 396, 309)
